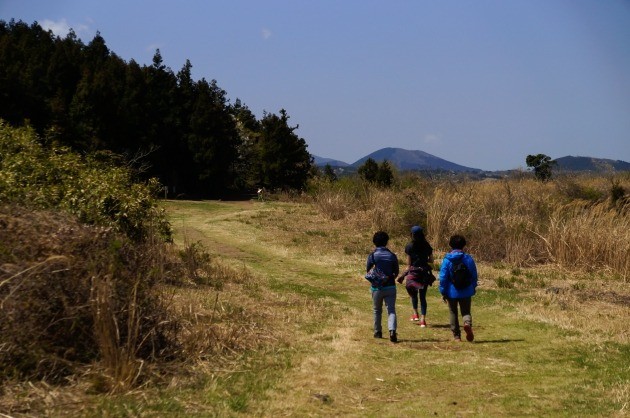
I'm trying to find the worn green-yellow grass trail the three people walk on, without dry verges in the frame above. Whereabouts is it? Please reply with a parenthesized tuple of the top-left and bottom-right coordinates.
(154, 202, 630, 416)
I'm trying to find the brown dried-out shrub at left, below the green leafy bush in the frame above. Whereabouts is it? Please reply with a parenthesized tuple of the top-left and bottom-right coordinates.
(0, 206, 175, 385)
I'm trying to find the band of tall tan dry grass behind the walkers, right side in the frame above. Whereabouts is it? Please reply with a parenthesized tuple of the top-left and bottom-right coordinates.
(310, 174, 630, 281)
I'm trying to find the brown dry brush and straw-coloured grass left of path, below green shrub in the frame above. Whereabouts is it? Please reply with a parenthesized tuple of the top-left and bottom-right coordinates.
(0, 203, 277, 415)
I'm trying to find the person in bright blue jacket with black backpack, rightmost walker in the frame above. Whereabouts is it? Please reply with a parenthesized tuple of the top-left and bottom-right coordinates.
(440, 235, 477, 342)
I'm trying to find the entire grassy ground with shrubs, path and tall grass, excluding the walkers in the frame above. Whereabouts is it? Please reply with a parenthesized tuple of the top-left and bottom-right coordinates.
(0, 121, 630, 416)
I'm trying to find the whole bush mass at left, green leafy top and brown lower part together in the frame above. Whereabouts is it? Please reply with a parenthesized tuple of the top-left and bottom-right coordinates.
(0, 121, 178, 390)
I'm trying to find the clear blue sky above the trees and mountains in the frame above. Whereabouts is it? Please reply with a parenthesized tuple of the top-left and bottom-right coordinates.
(0, 0, 630, 171)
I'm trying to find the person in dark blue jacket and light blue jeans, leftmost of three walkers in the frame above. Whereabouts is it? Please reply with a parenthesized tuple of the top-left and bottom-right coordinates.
(365, 231, 399, 343)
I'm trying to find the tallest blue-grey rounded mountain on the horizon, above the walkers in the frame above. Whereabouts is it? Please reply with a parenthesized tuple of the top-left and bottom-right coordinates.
(351, 148, 482, 172)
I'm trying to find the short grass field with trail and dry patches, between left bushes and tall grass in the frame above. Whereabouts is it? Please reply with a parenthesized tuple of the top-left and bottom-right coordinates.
(0, 201, 630, 417)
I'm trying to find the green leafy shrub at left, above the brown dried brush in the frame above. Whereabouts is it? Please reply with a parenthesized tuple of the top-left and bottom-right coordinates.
(0, 121, 171, 240)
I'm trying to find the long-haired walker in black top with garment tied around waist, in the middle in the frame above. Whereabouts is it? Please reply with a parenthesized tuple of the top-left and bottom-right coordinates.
(398, 225, 435, 328)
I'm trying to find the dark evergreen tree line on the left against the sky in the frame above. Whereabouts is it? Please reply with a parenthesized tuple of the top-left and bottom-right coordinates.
(0, 20, 315, 197)
